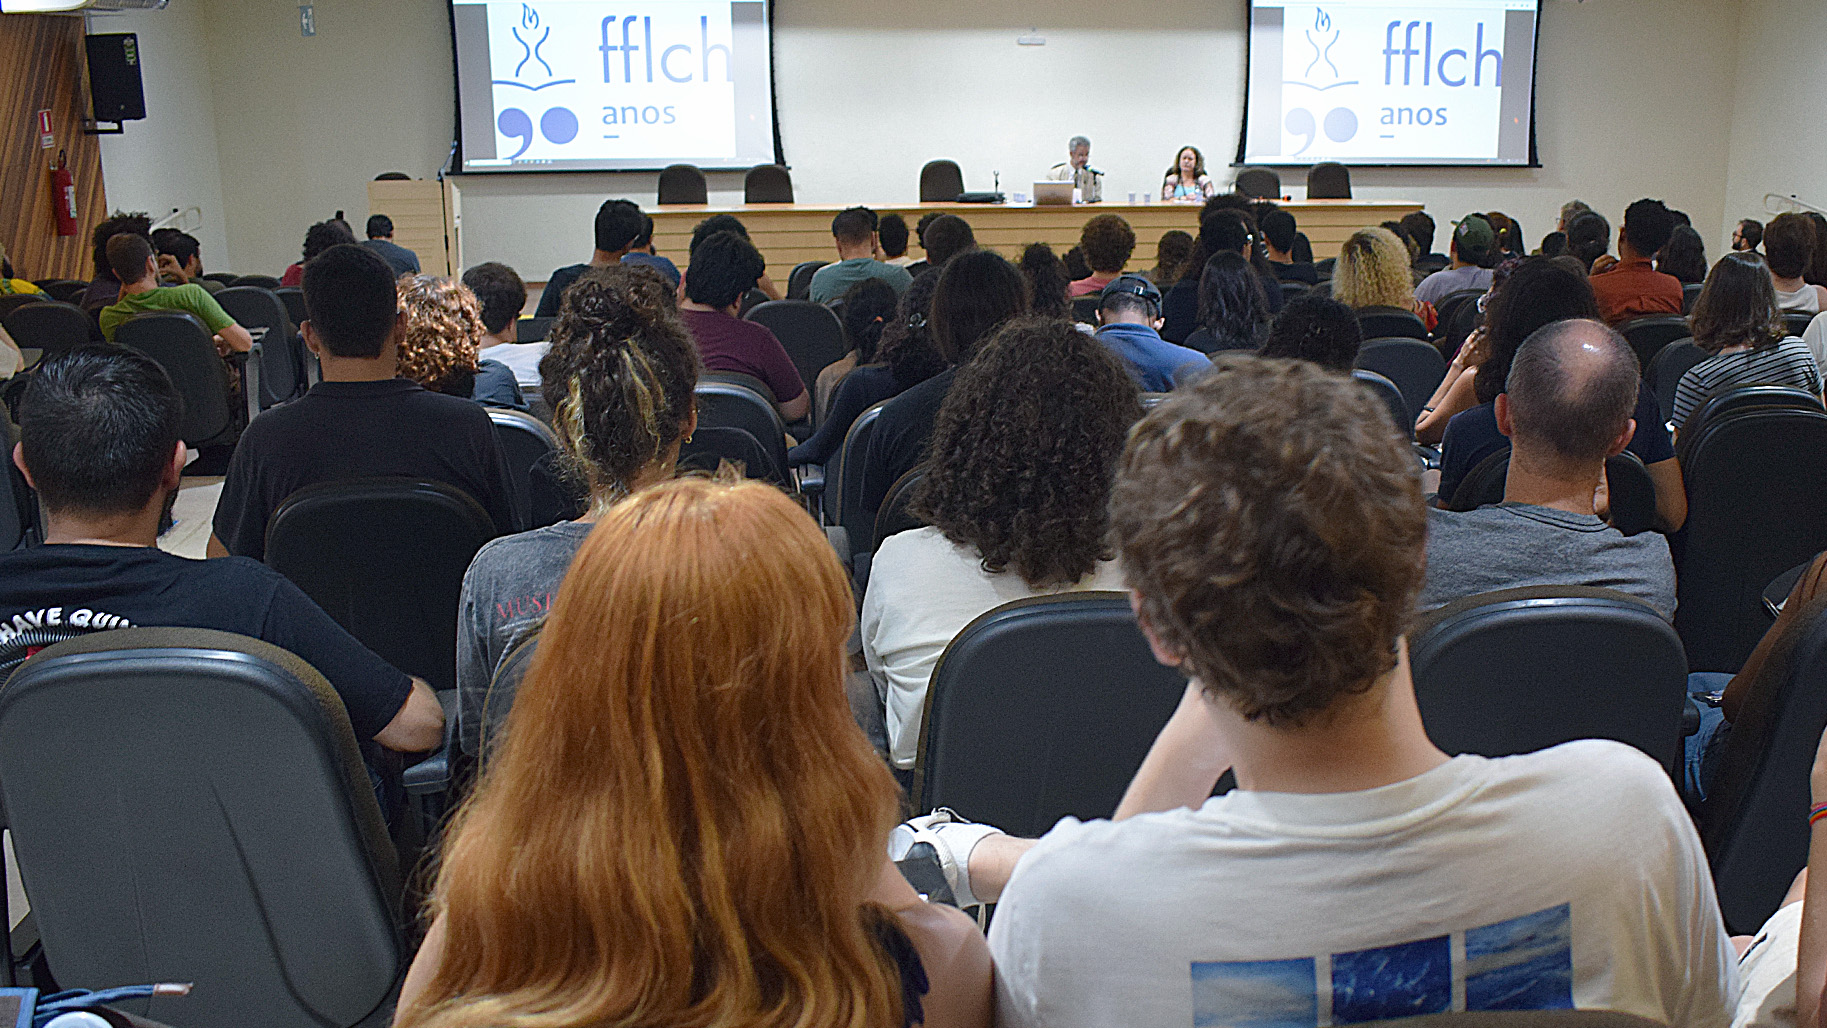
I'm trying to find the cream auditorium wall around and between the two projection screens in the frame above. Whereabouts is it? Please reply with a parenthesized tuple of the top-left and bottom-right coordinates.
(97, 0, 1739, 279)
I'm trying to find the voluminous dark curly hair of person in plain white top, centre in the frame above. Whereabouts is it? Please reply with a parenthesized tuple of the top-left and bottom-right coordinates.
(912, 318, 1142, 588)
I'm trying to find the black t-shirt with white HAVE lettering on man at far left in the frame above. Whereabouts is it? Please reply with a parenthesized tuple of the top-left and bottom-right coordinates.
(0, 544, 413, 741)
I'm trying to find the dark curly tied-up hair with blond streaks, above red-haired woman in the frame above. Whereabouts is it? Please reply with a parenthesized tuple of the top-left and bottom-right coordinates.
(539, 265, 698, 500)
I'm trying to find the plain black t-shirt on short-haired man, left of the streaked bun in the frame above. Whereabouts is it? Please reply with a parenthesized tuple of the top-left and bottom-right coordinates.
(214, 378, 519, 561)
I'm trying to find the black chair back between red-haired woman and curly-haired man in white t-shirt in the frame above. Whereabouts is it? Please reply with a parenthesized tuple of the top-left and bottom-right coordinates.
(914, 592, 1186, 838)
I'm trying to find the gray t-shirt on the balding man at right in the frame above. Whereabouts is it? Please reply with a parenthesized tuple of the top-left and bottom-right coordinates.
(1420, 504, 1675, 621)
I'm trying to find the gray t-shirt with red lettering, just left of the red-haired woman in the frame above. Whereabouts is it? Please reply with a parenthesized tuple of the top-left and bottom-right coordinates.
(457, 520, 596, 754)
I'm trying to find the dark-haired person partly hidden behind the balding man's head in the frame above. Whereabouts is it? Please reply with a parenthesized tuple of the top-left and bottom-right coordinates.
(1416, 257, 1688, 531)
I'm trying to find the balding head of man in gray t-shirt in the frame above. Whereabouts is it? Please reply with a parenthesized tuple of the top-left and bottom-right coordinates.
(1504, 320, 1641, 466)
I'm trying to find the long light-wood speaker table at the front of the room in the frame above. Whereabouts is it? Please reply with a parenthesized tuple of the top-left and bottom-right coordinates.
(649, 199, 1425, 288)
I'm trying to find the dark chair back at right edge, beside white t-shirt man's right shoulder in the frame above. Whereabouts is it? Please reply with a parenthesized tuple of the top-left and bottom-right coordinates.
(1699, 597, 1827, 935)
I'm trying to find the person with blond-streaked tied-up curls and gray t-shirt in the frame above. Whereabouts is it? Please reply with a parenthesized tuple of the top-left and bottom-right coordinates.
(457, 267, 698, 754)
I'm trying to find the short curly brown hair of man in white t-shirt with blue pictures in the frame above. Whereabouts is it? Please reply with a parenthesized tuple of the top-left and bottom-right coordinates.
(1111, 354, 1427, 725)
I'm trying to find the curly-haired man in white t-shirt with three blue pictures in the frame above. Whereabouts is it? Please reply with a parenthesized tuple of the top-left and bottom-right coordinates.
(890, 354, 1736, 1028)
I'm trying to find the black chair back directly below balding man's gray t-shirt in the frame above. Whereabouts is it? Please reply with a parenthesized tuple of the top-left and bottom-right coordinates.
(1409, 586, 1688, 774)
